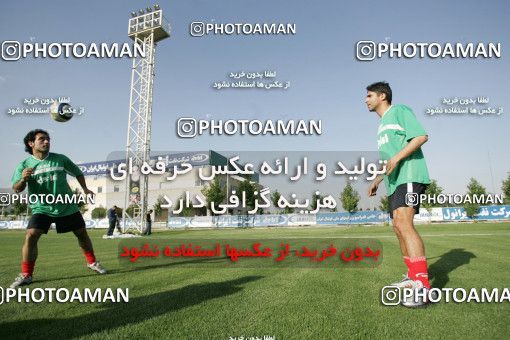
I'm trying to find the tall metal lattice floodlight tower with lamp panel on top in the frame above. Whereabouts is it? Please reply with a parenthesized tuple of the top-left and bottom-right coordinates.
(122, 5, 170, 232)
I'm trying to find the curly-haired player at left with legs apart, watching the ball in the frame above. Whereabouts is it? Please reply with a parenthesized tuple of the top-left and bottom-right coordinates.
(11, 129, 106, 288)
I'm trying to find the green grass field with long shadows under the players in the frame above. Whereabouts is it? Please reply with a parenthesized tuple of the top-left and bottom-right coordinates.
(0, 223, 510, 339)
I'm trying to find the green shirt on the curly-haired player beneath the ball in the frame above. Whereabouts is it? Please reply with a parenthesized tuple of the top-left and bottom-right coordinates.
(11, 152, 83, 217)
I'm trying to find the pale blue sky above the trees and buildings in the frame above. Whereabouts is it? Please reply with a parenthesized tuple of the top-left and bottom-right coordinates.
(0, 0, 510, 208)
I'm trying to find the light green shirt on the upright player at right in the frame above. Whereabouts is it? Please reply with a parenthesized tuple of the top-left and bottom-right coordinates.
(377, 105, 430, 196)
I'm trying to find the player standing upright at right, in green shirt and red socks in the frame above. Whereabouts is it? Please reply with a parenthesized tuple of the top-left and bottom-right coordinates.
(365, 82, 430, 307)
